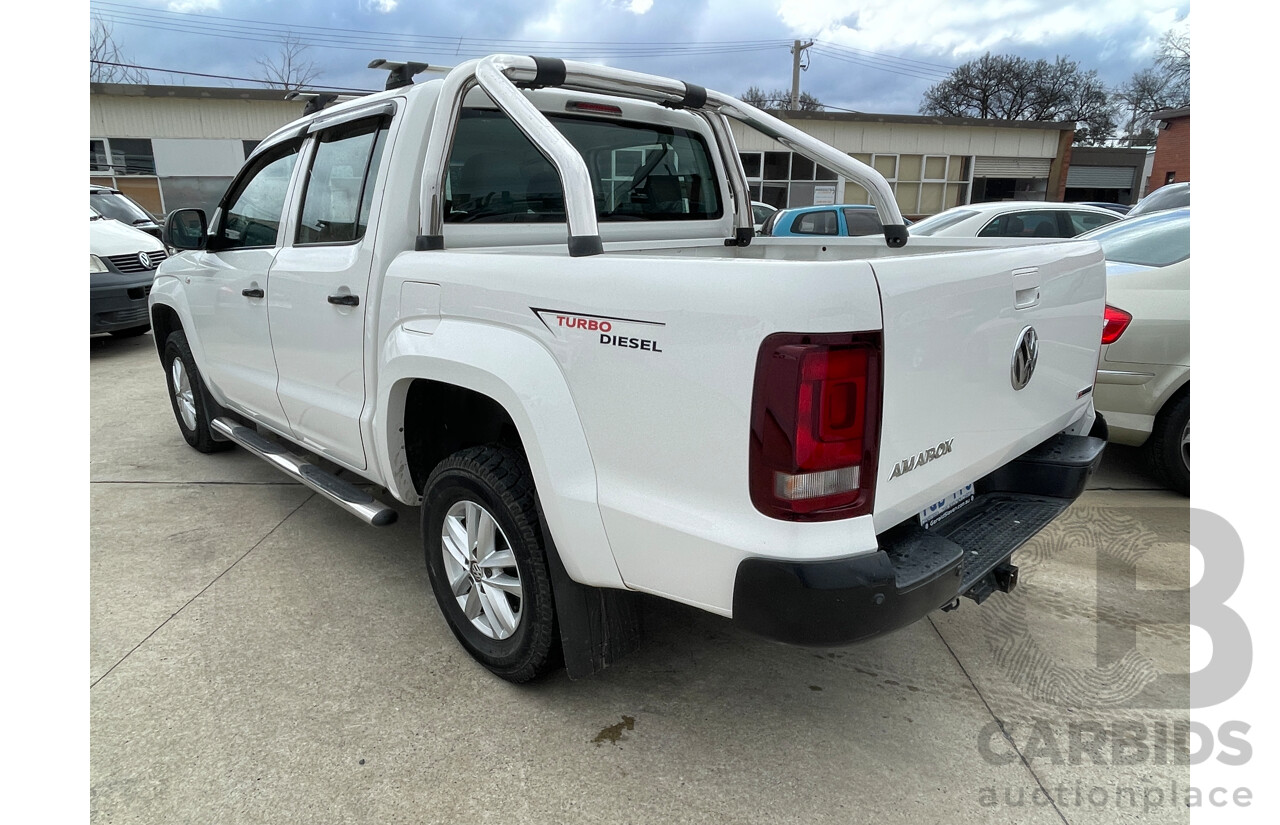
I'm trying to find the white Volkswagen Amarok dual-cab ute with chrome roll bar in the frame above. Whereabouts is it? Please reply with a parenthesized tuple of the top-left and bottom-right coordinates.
(150, 55, 1105, 682)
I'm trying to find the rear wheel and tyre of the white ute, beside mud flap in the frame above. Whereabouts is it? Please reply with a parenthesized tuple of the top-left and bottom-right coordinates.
(422, 446, 559, 683)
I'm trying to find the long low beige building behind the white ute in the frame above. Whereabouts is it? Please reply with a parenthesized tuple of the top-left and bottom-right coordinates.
(90, 83, 1075, 217)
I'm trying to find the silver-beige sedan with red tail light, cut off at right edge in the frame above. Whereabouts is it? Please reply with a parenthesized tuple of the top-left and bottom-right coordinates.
(1085, 206, 1192, 495)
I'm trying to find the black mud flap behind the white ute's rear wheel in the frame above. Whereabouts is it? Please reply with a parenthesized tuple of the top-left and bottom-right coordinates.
(538, 504, 641, 679)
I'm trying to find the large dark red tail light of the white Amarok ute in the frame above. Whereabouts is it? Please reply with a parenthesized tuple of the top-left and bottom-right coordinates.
(750, 333, 882, 521)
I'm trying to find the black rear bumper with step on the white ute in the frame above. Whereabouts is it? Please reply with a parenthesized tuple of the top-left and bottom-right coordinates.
(733, 434, 1106, 646)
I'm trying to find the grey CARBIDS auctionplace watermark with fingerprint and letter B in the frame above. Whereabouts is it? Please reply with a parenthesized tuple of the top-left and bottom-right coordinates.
(977, 508, 1253, 811)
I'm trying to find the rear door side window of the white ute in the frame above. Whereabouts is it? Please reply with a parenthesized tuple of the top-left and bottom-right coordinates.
(297, 118, 389, 246)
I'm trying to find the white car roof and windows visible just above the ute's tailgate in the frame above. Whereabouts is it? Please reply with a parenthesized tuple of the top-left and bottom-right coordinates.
(909, 201, 1120, 238)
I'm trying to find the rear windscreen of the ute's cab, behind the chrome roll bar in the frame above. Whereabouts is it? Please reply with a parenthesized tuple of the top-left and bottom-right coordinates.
(444, 109, 723, 223)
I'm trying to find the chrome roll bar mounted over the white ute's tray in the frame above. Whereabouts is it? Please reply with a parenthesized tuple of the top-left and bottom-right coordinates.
(416, 55, 908, 256)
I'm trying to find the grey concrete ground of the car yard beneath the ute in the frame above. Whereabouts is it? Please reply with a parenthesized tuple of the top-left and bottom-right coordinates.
(88, 334, 1189, 825)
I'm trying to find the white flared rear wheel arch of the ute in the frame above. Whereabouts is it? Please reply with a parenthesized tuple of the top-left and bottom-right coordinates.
(372, 320, 623, 587)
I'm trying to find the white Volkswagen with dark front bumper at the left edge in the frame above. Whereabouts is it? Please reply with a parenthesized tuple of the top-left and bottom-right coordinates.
(88, 201, 168, 336)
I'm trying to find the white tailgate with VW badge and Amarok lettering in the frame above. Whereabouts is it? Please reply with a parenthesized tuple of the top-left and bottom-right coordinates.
(872, 242, 1106, 532)
